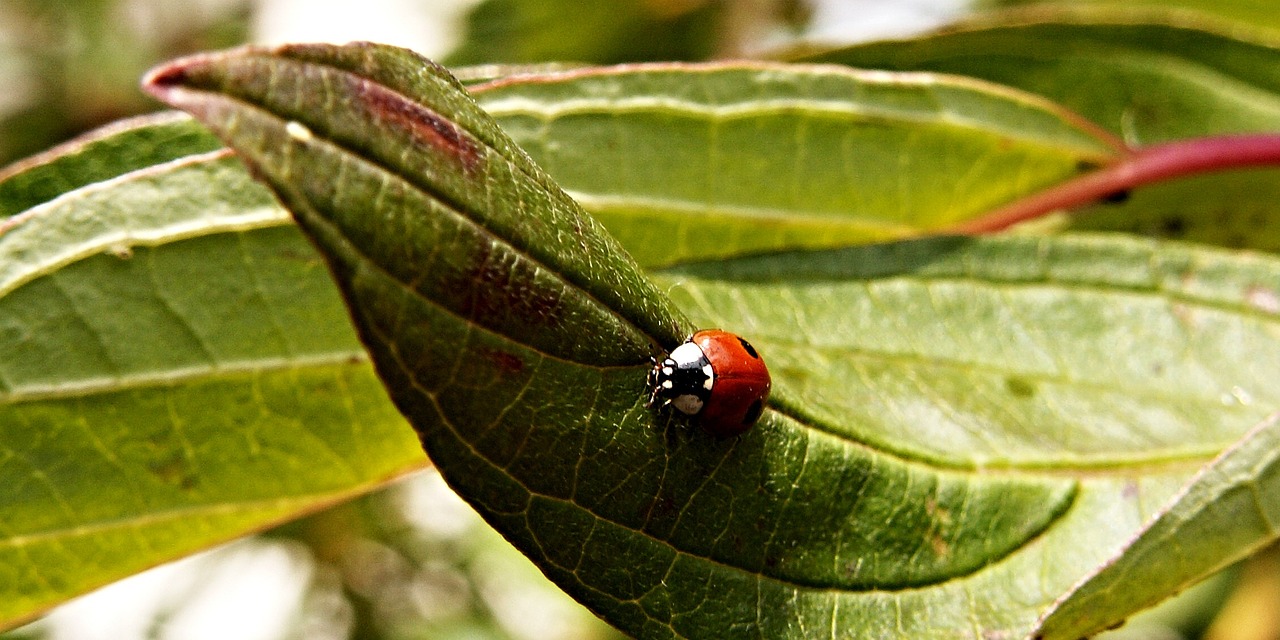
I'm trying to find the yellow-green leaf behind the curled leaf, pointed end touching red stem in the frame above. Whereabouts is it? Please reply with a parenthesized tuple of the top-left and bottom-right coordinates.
(475, 63, 1116, 266)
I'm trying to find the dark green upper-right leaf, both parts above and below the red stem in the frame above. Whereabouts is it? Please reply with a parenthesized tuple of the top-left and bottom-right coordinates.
(804, 10, 1280, 251)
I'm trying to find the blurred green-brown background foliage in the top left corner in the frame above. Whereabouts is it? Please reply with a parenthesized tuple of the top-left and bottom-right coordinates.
(0, 0, 252, 165)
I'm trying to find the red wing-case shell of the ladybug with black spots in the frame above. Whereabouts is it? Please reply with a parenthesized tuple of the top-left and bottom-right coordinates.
(690, 329, 773, 436)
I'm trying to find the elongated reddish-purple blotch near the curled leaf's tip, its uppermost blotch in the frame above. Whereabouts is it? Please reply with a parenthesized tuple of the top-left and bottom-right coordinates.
(352, 79, 480, 172)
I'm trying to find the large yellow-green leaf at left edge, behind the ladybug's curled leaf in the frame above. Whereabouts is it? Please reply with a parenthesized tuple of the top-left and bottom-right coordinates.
(0, 116, 425, 626)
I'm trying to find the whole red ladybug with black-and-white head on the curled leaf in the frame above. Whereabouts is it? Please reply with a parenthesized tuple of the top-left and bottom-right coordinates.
(649, 329, 772, 436)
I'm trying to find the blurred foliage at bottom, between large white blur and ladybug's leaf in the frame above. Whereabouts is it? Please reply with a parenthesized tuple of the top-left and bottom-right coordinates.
(275, 471, 622, 640)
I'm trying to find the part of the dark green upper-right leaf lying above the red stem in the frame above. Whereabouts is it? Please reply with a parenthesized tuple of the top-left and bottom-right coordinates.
(804, 10, 1280, 145)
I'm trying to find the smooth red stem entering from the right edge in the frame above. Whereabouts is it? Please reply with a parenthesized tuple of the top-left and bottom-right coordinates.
(946, 134, 1280, 234)
